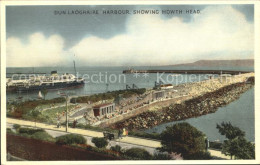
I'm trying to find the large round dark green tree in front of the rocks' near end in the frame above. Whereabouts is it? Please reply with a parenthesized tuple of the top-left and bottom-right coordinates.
(159, 123, 206, 159)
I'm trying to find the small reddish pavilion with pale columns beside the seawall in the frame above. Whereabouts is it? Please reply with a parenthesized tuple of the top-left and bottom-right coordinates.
(93, 103, 115, 117)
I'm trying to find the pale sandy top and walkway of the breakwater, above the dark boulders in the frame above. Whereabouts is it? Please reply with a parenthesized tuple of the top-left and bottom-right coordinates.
(99, 73, 254, 127)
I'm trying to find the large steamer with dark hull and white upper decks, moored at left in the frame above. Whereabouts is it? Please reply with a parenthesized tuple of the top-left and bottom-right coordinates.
(6, 71, 84, 92)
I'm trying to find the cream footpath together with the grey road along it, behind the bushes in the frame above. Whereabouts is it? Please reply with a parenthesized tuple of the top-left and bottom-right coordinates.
(7, 118, 230, 159)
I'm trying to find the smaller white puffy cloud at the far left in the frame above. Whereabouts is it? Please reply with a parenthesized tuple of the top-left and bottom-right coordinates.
(6, 33, 67, 67)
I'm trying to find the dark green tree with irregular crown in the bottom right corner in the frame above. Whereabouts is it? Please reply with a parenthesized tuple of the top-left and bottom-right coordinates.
(217, 122, 255, 159)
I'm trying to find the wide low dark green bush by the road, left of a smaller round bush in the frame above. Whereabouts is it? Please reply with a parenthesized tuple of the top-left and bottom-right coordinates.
(56, 134, 86, 145)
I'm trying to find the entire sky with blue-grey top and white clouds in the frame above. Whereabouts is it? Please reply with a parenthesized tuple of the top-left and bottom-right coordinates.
(6, 5, 254, 67)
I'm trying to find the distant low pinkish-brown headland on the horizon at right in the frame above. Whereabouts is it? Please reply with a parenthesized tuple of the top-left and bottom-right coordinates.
(171, 59, 254, 67)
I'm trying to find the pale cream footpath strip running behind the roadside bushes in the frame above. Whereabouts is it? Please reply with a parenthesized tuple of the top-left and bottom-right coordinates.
(6, 118, 230, 159)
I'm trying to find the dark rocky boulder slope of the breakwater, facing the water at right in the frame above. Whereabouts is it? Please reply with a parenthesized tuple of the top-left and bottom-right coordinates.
(111, 82, 253, 130)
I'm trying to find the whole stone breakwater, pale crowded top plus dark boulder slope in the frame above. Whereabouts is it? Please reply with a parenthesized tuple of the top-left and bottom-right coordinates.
(100, 73, 254, 129)
